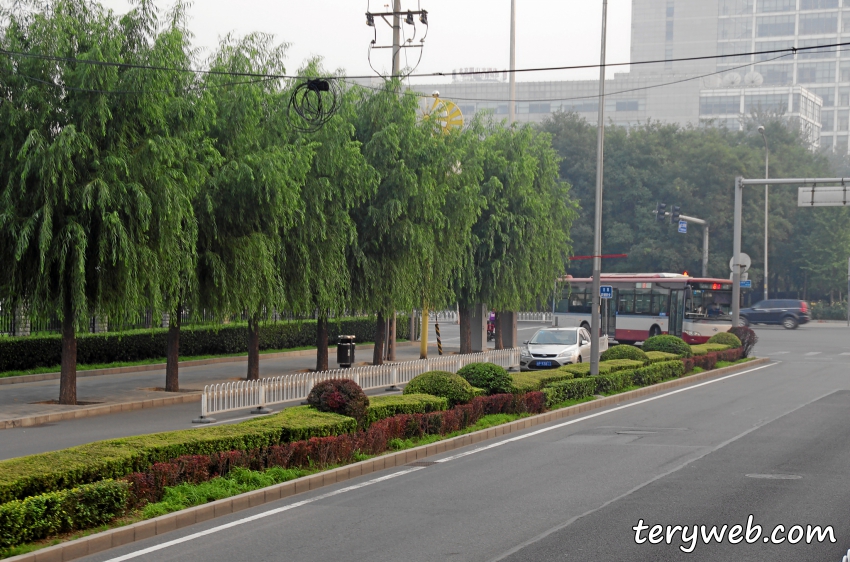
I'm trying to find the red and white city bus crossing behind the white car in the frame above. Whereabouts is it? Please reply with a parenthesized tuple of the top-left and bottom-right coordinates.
(554, 273, 732, 344)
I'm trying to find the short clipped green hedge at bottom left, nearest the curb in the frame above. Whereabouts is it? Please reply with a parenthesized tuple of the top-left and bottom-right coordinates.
(0, 480, 129, 548)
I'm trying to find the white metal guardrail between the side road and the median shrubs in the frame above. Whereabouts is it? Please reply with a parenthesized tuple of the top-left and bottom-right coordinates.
(192, 348, 520, 423)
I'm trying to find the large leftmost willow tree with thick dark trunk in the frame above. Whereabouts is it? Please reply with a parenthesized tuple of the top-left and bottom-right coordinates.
(0, 0, 204, 404)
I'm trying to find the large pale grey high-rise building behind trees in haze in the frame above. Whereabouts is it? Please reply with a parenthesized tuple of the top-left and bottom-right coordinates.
(417, 0, 832, 152)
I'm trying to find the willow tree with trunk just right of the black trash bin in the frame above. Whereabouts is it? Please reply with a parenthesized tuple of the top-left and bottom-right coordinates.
(349, 84, 474, 364)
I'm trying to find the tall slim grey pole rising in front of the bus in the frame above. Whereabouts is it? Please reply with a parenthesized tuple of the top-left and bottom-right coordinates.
(590, 0, 608, 376)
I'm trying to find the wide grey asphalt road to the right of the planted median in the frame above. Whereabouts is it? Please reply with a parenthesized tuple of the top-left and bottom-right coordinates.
(74, 325, 850, 562)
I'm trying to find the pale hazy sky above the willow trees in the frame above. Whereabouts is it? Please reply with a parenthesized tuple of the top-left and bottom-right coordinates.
(96, 0, 631, 83)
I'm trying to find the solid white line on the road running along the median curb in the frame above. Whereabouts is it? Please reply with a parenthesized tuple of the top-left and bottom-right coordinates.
(101, 363, 777, 562)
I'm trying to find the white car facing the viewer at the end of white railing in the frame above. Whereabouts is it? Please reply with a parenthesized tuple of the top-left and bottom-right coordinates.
(519, 328, 608, 371)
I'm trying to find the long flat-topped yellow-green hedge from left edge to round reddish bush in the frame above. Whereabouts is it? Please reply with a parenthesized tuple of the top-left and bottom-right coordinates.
(0, 406, 357, 503)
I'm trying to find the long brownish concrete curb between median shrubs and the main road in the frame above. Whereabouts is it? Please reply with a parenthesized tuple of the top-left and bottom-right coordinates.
(1, 358, 770, 562)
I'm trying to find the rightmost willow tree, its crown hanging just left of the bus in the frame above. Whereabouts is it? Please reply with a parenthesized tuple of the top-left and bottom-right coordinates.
(457, 121, 576, 352)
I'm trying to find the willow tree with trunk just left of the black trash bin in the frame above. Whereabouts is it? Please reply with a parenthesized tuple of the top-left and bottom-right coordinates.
(282, 71, 377, 371)
